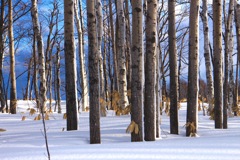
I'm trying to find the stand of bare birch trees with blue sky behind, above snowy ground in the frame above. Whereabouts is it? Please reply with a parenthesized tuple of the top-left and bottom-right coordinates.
(0, 0, 240, 159)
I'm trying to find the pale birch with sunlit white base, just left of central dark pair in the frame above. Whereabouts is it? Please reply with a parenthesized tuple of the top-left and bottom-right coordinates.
(117, 0, 128, 109)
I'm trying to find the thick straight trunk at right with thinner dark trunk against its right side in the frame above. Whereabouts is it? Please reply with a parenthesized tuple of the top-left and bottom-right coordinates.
(213, 0, 223, 128)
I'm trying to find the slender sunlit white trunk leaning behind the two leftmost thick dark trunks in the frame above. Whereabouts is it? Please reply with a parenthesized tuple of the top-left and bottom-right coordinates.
(74, 0, 88, 111)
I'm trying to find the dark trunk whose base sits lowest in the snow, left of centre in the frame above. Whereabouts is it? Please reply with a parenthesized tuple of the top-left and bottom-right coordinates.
(87, 0, 101, 144)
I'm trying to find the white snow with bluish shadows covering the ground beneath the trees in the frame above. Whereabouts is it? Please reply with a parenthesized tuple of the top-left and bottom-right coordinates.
(0, 101, 240, 160)
